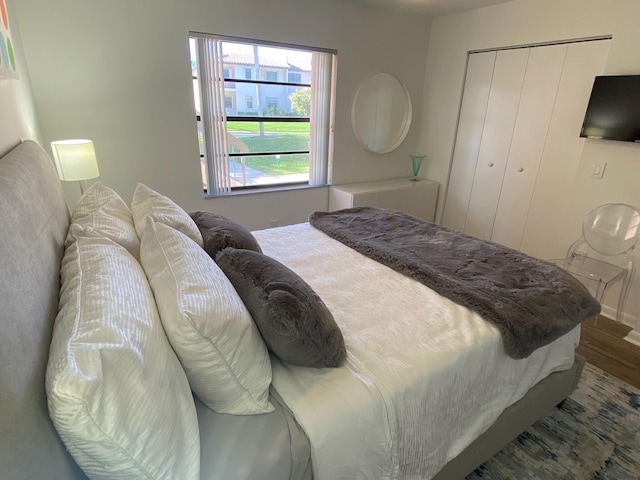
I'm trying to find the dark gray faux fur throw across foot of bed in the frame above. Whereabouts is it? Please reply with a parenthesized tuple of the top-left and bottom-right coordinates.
(309, 207, 600, 359)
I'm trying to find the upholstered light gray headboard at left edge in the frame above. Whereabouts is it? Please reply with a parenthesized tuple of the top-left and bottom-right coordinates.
(0, 141, 86, 479)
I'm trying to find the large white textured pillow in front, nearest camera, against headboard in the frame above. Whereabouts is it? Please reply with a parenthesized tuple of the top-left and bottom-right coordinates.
(46, 237, 200, 480)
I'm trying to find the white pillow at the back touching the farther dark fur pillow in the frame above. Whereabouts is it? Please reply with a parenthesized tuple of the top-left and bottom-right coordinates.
(131, 183, 203, 247)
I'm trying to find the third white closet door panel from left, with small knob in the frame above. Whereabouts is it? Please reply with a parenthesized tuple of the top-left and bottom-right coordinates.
(487, 44, 568, 249)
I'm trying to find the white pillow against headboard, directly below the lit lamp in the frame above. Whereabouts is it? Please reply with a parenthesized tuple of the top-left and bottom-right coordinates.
(65, 182, 140, 258)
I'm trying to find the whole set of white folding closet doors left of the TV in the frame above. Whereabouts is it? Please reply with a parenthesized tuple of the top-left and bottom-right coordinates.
(442, 40, 610, 250)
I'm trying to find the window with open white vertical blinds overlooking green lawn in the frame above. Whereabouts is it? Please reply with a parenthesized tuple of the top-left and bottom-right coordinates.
(189, 33, 336, 195)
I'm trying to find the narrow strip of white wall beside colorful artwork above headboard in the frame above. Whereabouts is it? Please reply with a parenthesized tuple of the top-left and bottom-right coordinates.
(0, 0, 38, 155)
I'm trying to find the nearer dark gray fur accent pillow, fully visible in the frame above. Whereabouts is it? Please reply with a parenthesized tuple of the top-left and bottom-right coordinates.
(215, 248, 347, 368)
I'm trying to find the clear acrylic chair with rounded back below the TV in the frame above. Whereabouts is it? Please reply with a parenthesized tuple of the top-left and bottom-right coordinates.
(551, 203, 640, 322)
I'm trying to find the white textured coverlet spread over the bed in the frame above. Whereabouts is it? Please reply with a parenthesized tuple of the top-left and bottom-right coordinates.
(254, 223, 579, 480)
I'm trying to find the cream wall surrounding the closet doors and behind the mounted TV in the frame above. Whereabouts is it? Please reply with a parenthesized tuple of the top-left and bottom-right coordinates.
(419, 0, 640, 329)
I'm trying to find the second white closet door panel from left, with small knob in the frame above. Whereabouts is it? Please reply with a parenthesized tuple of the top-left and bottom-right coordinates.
(464, 48, 529, 240)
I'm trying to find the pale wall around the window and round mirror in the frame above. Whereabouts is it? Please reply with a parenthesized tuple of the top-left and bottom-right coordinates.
(16, 0, 429, 229)
